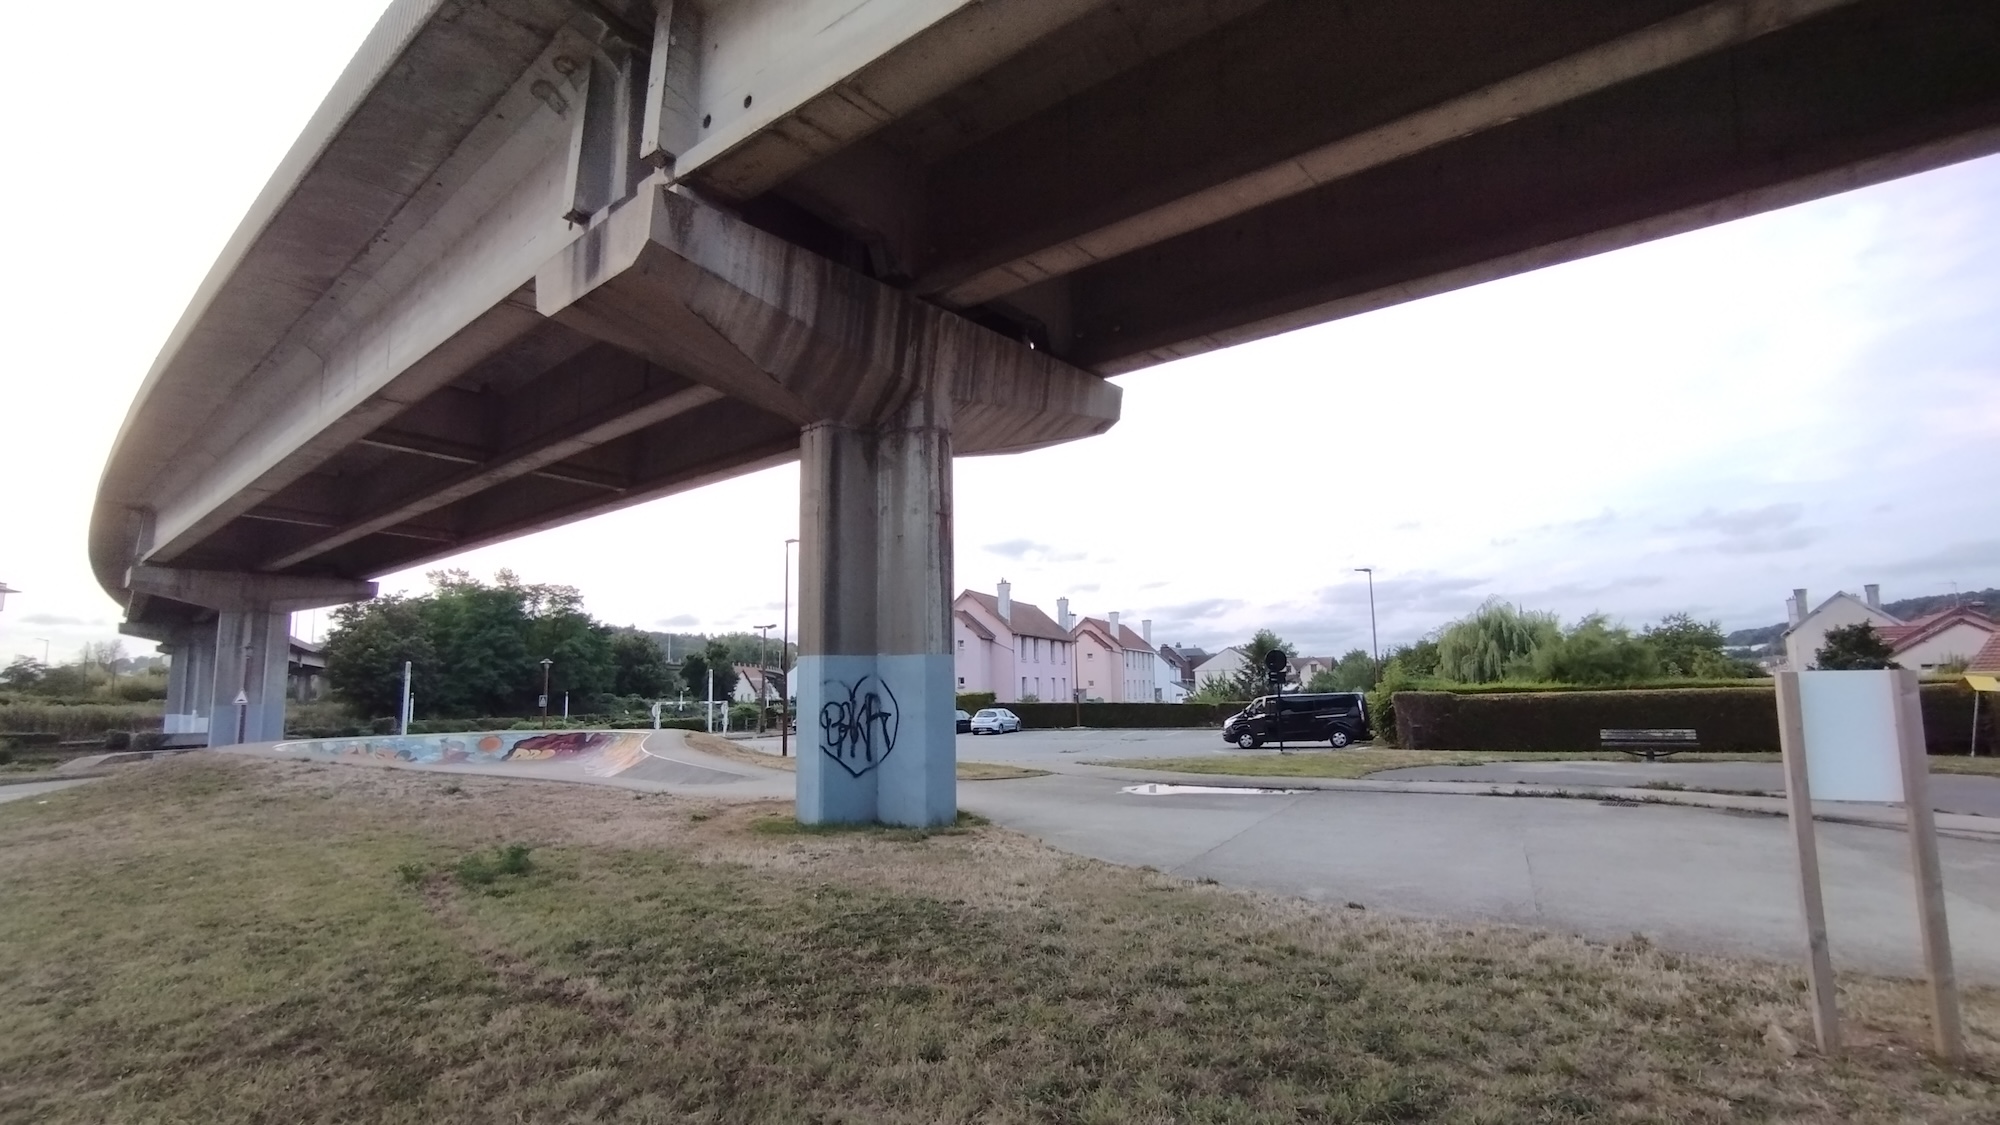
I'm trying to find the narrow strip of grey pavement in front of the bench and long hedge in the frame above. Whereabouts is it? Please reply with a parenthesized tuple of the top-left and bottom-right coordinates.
(1368, 761, 2000, 817)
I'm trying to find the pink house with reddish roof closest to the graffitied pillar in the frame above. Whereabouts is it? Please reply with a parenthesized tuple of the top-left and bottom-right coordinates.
(952, 579, 1076, 703)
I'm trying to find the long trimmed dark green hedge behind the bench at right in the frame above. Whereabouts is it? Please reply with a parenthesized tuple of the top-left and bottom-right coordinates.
(1396, 683, 1996, 755)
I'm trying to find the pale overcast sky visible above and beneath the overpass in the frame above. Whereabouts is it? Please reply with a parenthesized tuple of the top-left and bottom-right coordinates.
(0, 0, 2000, 659)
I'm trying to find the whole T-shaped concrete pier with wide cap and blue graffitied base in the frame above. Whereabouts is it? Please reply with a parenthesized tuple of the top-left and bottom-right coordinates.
(536, 190, 1120, 827)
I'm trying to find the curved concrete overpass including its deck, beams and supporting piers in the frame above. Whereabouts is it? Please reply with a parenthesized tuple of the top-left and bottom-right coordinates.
(90, 0, 2000, 821)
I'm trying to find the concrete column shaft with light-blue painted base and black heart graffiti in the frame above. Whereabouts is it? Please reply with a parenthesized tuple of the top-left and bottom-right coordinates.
(796, 378, 958, 827)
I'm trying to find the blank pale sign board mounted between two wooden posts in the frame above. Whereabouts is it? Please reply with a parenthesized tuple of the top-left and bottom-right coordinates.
(1798, 671, 1902, 803)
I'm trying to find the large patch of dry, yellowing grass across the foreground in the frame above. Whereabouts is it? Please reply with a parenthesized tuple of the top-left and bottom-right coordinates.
(0, 755, 2000, 1125)
